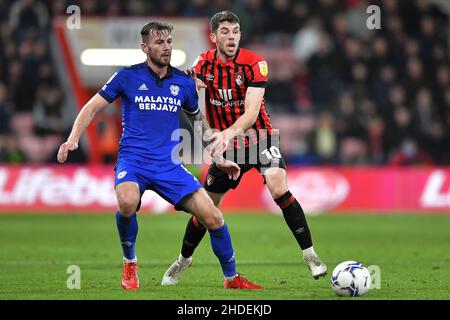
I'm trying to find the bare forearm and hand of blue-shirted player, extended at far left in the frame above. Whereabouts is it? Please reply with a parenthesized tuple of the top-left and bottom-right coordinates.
(57, 93, 109, 163)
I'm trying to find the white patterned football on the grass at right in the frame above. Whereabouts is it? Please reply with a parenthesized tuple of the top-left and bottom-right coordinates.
(331, 261, 372, 297)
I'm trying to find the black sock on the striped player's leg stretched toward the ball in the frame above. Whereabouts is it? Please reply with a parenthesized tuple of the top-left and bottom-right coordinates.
(275, 191, 312, 250)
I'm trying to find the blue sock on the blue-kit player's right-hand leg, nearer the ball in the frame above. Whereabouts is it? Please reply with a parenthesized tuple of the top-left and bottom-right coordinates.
(208, 224, 236, 278)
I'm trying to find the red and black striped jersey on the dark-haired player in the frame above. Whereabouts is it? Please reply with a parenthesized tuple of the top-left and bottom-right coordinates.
(193, 48, 273, 148)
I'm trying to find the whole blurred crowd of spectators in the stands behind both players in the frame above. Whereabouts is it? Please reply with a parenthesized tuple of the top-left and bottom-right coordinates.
(0, 0, 450, 165)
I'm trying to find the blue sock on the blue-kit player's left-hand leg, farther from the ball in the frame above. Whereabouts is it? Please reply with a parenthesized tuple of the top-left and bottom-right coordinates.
(116, 211, 138, 260)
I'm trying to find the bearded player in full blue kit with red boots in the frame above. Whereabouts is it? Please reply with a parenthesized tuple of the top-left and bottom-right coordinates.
(57, 22, 262, 290)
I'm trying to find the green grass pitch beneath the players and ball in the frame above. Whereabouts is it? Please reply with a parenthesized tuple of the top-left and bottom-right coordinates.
(0, 214, 450, 300)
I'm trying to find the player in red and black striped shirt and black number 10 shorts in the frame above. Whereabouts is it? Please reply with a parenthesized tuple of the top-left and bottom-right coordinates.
(161, 11, 327, 285)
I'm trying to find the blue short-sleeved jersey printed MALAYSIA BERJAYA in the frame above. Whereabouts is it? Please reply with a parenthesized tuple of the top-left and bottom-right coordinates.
(99, 62, 199, 164)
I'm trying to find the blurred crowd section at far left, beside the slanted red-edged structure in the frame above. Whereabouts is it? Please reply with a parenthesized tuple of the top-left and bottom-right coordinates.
(0, 0, 72, 163)
